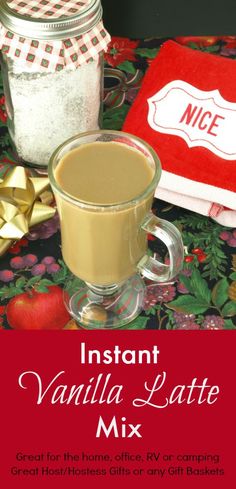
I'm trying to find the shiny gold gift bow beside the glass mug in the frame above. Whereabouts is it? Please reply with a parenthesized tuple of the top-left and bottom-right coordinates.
(0, 166, 56, 256)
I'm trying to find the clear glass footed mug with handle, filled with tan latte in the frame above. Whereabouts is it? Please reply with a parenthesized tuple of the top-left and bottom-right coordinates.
(48, 130, 184, 329)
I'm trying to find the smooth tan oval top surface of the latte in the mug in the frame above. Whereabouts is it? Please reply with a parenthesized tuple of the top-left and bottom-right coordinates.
(55, 141, 154, 204)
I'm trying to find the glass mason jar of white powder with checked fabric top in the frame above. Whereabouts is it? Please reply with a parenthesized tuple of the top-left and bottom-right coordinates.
(0, 0, 110, 168)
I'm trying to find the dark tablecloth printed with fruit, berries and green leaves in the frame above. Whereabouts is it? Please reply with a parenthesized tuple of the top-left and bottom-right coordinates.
(0, 37, 236, 330)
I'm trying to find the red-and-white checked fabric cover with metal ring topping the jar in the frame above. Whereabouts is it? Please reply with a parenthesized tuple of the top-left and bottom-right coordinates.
(0, 0, 110, 71)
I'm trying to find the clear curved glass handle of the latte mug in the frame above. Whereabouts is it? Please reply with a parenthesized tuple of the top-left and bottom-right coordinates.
(138, 213, 184, 282)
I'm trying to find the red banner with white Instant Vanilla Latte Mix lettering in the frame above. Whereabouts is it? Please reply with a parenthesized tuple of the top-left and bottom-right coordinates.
(0, 331, 235, 489)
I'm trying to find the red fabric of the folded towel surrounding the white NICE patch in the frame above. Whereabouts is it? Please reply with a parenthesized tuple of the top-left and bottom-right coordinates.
(123, 41, 236, 192)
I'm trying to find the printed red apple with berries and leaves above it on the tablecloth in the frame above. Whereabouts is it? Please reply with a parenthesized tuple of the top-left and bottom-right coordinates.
(0, 253, 71, 330)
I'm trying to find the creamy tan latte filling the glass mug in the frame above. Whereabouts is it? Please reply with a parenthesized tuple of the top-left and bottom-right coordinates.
(55, 141, 155, 286)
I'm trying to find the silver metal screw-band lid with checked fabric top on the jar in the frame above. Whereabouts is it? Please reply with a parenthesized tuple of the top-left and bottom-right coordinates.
(0, 0, 102, 40)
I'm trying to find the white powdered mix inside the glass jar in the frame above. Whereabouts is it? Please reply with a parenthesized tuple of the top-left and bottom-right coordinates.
(8, 60, 102, 165)
